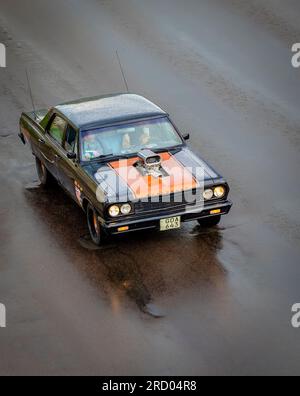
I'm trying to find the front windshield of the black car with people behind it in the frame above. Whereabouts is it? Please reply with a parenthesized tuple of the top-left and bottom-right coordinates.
(80, 117, 182, 161)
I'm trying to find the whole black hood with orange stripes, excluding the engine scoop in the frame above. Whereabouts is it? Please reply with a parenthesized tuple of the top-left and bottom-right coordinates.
(86, 147, 219, 202)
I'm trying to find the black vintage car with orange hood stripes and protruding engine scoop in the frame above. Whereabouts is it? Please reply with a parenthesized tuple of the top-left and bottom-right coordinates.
(20, 94, 232, 245)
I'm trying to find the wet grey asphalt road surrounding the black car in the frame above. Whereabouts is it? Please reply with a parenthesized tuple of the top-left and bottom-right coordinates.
(0, 0, 300, 375)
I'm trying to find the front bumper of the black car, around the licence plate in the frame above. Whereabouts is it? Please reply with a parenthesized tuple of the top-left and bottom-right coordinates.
(102, 200, 232, 235)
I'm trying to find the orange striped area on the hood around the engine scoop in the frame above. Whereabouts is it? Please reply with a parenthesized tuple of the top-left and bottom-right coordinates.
(110, 153, 198, 199)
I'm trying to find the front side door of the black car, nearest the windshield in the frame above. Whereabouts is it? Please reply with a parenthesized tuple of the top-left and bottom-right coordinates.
(57, 124, 78, 201)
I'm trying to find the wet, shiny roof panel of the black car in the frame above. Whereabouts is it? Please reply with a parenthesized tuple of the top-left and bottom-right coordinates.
(54, 93, 167, 129)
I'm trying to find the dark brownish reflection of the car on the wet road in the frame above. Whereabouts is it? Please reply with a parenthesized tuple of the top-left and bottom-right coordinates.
(24, 183, 226, 317)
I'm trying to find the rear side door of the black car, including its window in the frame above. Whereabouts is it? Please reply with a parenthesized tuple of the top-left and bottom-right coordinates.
(39, 114, 67, 181)
